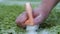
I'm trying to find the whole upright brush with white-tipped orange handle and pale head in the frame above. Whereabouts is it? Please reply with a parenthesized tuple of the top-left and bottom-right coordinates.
(25, 2, 38, 34)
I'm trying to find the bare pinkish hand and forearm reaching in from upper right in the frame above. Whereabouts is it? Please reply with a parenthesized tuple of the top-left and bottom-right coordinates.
(16, 0, 60, 28)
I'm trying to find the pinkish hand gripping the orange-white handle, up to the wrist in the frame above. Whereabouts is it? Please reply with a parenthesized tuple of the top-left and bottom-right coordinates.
(16, 8, 48, 28)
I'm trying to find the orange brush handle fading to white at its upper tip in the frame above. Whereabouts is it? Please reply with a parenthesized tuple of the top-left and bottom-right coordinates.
(25, 2, 34, 25)
